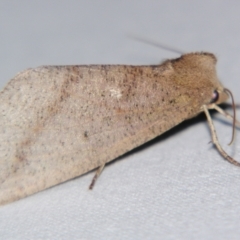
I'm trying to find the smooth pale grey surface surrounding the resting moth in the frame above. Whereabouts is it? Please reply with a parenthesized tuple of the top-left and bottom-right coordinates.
(0, 1, 240, 239)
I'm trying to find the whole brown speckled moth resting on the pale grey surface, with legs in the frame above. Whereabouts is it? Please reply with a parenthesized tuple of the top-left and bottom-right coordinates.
(0, 52, 240, 205)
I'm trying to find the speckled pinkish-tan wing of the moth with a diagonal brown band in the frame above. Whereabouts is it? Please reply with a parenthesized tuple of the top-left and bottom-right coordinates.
(0, 66, 188, 204)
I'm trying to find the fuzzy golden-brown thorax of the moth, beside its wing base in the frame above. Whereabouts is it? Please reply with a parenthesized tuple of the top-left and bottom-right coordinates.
(161, 52, 228, 104)
